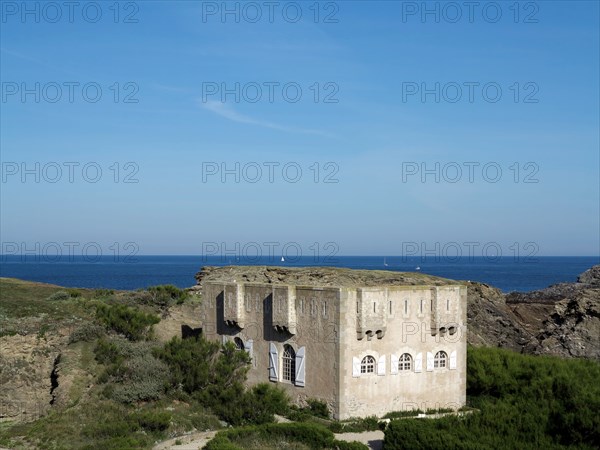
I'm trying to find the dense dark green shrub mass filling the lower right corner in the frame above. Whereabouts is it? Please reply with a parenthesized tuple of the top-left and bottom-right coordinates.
(385, 348, 600, 450)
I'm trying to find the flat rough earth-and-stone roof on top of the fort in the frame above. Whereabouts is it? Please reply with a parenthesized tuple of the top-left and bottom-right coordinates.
(196, 266, 462, 288)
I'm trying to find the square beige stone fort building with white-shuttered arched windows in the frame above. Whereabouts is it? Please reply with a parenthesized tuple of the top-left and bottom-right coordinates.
(198, 267, 467, 420)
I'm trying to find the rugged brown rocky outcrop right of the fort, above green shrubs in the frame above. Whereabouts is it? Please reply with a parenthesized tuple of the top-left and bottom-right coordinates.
(468, 266, 600, 360)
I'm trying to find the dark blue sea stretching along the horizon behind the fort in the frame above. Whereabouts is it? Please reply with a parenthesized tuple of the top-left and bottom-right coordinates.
(0, 255, 600, 292)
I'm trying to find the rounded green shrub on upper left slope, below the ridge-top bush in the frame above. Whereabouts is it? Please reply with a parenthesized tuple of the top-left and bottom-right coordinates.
(96, 303, 160, 341)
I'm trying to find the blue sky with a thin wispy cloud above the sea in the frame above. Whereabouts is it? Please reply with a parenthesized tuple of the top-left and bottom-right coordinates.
(0, 1, 600, 256)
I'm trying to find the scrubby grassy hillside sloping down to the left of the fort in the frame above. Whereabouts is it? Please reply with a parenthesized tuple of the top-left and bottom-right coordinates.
(0, 278, 221, 449)
